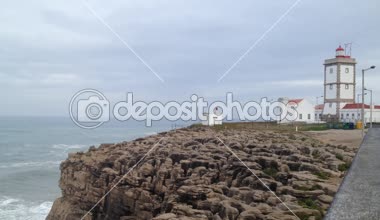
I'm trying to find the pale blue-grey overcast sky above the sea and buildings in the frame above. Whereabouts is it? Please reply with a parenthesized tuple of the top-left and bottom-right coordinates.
(0, 0, 380, 116)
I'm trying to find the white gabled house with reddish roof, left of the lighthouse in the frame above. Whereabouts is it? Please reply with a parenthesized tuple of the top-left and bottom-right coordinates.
(278, 98, 315, 123)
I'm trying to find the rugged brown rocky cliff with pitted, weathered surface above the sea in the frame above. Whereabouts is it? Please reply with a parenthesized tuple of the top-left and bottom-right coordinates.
(47, 127, 354, 220)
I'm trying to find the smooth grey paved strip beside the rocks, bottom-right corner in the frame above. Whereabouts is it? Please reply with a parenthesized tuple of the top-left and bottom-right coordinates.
(325, 128, 380, 220)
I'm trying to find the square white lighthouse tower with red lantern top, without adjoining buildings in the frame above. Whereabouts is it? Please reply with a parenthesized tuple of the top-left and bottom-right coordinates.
(322, 46, 356, 120)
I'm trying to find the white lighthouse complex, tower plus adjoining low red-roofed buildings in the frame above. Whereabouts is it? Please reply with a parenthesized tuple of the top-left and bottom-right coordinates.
(314, 46, 380, 123)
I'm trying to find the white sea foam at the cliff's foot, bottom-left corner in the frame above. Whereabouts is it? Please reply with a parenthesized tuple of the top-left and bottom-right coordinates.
(0, 197, 53, 220)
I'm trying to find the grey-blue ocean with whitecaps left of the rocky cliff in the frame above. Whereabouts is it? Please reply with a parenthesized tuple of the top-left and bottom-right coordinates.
(0, 117, 180, 220)
